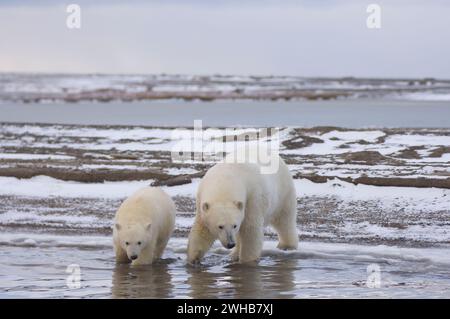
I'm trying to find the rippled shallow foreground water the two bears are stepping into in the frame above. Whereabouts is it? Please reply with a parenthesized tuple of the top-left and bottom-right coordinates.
(0, 240, 450, 298)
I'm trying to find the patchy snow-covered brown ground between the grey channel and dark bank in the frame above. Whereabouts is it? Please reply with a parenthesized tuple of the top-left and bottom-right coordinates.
(0, 123, 450, 179)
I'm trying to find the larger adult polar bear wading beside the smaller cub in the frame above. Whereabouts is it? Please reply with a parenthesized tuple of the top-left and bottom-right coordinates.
(188, 151, 298, 263)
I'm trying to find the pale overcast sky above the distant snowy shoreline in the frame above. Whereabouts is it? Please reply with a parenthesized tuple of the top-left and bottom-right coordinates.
(0, 0, 450, 78)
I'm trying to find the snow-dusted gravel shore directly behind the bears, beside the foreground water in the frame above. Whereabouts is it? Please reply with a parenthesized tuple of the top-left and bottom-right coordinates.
(0, 176, 450, 247)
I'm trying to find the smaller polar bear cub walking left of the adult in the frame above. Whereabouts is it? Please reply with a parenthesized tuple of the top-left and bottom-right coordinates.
(113, 187, 176, 265)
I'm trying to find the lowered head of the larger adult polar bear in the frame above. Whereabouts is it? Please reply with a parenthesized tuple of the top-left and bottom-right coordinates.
(200, 201, 244, 249)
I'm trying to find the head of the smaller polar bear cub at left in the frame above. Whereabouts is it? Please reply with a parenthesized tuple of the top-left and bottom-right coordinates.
(114, 223, 152, 260)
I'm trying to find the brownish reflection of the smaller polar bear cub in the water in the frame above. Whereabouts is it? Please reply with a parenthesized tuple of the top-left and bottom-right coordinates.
(111, 261, 173, 298)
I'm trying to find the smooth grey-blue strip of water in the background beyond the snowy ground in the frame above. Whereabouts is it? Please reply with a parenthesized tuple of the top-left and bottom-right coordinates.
(0, 100, 450, 128)
